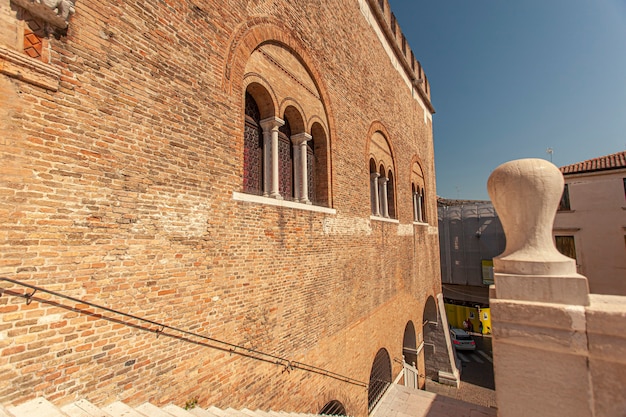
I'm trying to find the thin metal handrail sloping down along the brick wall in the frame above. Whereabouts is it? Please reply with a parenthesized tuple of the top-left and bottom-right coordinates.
(0, 277, 368, 388)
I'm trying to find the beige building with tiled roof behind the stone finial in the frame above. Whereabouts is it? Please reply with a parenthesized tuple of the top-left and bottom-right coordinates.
(553, 152, 626, 295)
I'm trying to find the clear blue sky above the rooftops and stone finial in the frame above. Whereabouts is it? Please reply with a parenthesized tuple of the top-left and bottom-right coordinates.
(389, 0, 626, 199)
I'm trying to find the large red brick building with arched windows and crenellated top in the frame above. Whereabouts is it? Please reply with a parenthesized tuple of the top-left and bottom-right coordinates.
(0, 0, 451, 415)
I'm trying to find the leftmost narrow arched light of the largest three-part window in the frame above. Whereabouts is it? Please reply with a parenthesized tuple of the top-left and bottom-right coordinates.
(243, 92, 263, 195)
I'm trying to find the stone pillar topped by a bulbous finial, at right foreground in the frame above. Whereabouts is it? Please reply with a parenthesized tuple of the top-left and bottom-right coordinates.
(487, 159, 594, 417)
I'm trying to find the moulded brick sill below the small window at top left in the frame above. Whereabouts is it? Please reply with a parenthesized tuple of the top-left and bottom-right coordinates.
(0, 46, 61, 91)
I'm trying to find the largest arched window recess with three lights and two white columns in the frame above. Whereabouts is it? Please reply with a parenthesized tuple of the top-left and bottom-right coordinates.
(243, 43, 330, 205)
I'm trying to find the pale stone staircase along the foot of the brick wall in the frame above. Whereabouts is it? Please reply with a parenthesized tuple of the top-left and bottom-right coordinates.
(0, 398, 322, 417)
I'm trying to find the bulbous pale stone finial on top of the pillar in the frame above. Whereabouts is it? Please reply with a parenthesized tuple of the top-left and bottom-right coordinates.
(487, 159, 576, 276)
